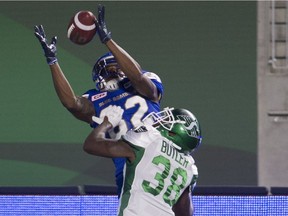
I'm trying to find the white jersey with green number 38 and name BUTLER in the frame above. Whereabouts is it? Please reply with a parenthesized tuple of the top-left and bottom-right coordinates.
(118, 126, 198, 216)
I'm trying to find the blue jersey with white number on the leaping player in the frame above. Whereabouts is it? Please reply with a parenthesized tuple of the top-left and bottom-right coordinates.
(85, 72, 163, 195)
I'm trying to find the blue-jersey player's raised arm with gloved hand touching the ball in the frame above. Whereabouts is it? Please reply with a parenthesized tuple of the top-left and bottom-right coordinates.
(96, 5, 159, 101)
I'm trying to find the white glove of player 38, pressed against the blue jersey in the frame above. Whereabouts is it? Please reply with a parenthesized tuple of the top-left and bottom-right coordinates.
(92, 105, 124, 128)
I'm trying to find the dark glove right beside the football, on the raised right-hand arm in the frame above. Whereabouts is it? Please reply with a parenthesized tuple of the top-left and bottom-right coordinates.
(96, 5, 111, 44)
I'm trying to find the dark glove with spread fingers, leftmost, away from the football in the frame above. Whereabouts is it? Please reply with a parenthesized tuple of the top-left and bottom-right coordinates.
(34, 25, 57, 65)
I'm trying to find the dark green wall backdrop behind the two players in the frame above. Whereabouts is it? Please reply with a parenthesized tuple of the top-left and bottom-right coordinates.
(0, 1, 257, 186)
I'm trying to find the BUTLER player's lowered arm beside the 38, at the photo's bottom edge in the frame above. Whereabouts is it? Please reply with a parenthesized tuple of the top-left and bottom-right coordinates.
(173, 187, 194, 216)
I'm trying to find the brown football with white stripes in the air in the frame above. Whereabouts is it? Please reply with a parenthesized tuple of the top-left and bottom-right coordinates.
(67, 11, 96, 45)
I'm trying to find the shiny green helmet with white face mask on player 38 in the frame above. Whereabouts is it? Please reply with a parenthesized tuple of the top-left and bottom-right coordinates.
(144, 108, 202, 154)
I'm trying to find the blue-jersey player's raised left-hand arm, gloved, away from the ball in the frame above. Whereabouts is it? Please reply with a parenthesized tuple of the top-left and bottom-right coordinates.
(34, 25, 95, 123)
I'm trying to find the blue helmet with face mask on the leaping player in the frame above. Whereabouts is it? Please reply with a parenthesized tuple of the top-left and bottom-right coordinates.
(92, 52, 125, 91)
